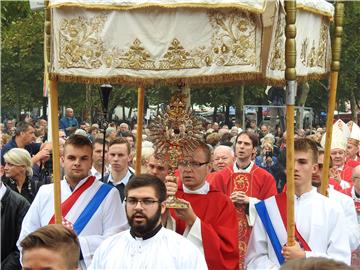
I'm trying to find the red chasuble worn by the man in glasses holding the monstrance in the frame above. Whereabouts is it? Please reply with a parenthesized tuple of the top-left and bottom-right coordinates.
(171, 188, 239, 270)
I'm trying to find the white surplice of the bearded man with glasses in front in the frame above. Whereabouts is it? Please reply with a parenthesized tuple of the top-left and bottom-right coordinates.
(89, 228, 208, 270)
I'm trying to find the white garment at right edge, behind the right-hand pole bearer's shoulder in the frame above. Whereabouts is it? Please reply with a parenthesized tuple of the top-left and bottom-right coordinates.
(328, 187, 360, 251)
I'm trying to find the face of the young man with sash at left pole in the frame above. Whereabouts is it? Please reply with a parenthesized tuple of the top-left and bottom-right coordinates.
(62, 144, 92, 183)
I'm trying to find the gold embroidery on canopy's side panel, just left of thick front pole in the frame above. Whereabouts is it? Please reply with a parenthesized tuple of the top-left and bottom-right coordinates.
(270, 13, 285, 71)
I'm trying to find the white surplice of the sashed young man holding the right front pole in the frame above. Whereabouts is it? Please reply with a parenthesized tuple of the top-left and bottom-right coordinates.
(245, 188, 351, 270)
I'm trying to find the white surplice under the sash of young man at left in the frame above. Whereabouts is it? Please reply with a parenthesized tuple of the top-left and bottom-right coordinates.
(18, 178, 129, 269)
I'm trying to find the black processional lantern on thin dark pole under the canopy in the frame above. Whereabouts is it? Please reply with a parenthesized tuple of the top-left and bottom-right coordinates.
(100, 84, 112, 180)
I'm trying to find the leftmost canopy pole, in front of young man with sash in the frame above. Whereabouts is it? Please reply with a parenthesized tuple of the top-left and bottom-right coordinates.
(44, 1, 61, 224)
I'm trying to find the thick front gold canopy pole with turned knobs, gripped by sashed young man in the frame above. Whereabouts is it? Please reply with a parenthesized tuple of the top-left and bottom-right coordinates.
(285, 0, 297, 246)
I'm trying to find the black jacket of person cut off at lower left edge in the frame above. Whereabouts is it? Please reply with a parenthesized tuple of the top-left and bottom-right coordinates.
(1, 187, 30, 270)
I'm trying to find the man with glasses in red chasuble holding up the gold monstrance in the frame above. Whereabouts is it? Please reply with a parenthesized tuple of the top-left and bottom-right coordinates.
(164, 142, 239, 270)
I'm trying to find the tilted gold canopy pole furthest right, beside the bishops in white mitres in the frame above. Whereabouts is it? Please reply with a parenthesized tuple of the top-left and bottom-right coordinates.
(320, 1, 344, 196)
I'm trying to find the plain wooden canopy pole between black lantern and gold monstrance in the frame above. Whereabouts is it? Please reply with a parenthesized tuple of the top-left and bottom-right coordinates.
(135, 86, 144, 175)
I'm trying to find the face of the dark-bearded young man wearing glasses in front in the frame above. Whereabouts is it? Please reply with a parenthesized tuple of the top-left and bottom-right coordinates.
(125, 187, 166, 237)
